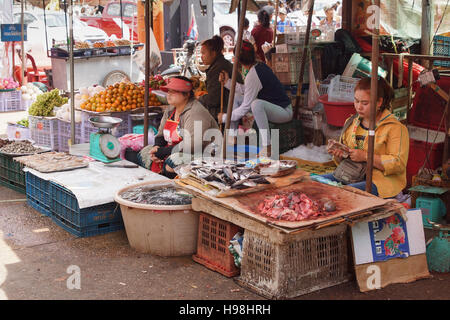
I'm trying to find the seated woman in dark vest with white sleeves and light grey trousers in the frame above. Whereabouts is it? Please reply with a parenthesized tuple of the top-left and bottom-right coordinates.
(218, 41, 293, 157)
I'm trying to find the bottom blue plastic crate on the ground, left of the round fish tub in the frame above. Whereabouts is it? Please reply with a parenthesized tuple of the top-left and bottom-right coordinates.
(52, 215, 124, 238)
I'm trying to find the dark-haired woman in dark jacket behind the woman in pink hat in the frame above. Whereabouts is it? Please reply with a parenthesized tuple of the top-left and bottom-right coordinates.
(198, 35, 244, 119)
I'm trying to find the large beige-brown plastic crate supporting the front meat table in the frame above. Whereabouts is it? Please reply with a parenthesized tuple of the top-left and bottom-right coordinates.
(236, 224, 350, 299)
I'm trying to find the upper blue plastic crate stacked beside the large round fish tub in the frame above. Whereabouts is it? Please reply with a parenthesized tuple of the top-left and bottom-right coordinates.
(50, 182, 122, 228)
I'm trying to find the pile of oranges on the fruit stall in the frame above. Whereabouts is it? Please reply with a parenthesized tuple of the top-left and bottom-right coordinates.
(80, 82, 161, 112)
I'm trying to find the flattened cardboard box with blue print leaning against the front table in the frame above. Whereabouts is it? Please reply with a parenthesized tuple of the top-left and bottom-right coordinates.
(352, 209, 429, 292)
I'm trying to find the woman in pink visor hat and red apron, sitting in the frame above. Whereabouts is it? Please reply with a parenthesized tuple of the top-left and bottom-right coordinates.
(138, 76, 219, 178)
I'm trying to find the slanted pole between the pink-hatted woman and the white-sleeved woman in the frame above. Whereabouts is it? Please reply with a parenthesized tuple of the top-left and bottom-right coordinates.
(222, 0, 247, 160)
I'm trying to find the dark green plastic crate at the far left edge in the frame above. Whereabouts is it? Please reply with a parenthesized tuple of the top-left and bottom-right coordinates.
(0, 154, 26, 194)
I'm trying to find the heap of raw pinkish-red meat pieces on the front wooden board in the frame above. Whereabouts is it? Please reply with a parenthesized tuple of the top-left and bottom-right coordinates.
(258, 192, 336, 221)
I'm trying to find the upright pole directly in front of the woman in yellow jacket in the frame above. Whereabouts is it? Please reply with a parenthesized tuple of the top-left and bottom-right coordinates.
(366, 0, 380, 192)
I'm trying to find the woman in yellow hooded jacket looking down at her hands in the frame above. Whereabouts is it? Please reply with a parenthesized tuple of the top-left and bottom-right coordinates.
(324, 78, 409, 198)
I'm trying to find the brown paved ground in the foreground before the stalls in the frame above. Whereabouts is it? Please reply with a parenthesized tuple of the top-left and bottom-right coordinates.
(0, 187, 450, 300)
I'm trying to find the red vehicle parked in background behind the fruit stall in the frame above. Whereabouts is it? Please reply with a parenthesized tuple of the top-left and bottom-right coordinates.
(80, 1, 138, 41)
